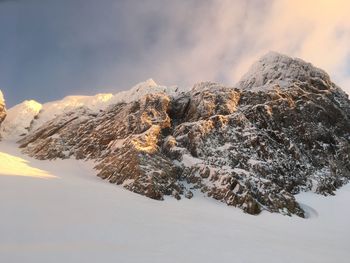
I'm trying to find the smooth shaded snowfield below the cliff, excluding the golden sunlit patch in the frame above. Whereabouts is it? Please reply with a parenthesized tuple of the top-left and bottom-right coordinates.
(0, 142, 350, 263)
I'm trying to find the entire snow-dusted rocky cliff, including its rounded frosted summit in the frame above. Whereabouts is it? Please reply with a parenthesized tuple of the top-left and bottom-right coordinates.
(14, 53, 350, 217)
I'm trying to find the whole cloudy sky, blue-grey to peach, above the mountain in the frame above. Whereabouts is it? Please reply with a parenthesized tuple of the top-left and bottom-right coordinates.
(0, 0, 350, 107)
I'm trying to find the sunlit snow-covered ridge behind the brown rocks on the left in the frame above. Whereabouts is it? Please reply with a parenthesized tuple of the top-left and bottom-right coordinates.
(0, 79, 178, 140)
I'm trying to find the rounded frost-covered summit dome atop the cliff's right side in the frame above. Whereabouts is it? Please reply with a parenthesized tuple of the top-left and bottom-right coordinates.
(237, 51, 331, 90)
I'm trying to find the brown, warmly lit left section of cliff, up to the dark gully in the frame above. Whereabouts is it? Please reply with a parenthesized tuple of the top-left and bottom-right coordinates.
(20, 94, 185, 199)
